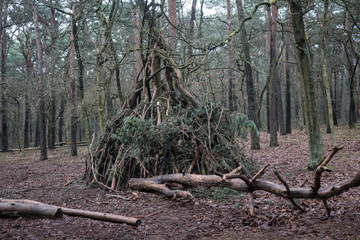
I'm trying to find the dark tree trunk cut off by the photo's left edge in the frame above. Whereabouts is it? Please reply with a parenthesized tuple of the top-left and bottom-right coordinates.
(0, 0, 9, 152)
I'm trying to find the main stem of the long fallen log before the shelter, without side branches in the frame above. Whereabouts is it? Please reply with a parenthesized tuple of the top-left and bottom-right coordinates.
(129, 172, 360, 199)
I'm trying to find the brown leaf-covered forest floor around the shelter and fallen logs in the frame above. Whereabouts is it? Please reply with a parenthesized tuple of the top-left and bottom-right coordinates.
(0, 125, 360, 240)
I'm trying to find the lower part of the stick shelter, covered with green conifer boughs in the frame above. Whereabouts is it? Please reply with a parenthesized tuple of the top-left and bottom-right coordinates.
(87, 101, 258, 190)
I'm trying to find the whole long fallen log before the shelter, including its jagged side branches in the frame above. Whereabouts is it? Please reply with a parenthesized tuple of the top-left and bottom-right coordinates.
(128, 147, 360, 215)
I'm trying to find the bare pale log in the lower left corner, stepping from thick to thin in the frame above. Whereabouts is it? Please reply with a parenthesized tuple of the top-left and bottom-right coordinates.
(0, 198, 141, 226)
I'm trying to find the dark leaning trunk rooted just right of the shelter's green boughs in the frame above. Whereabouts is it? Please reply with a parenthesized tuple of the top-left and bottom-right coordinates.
(236, 0, 260, 149)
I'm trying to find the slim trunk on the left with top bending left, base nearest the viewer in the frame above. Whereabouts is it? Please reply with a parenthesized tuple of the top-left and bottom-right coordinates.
(29, 0, 48, 160)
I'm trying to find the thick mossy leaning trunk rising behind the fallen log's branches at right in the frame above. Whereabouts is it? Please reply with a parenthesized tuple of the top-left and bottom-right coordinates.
(288, 0, 324, 170)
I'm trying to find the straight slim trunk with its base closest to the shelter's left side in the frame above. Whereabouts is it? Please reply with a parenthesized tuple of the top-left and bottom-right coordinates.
(69, 4, 77, 156)
